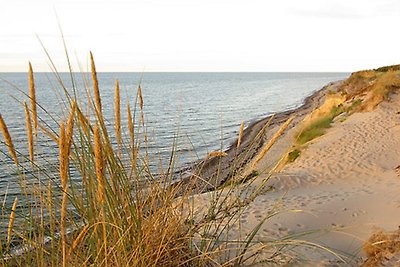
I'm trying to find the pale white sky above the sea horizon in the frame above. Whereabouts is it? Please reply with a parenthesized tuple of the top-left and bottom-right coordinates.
(0, 0, 400, 72)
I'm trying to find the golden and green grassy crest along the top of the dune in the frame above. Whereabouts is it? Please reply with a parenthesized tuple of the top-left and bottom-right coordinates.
(286, 65, 400, 163)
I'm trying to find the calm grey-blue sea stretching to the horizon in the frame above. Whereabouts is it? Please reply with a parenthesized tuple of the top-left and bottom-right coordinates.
(0, 73, 349, 199)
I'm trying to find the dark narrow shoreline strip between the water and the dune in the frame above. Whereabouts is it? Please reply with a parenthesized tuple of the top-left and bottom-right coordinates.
(177, 80, 344, 193)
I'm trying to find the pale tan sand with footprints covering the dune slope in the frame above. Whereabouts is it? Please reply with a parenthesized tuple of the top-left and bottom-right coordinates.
(188, 81, 400, 266)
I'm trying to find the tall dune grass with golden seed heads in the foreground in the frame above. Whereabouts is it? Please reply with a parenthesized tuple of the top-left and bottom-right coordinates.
(0, 53, 344, 266)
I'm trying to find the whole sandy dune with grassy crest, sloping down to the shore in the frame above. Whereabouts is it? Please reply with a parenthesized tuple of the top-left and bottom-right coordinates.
(190, 66, 400, 266)
